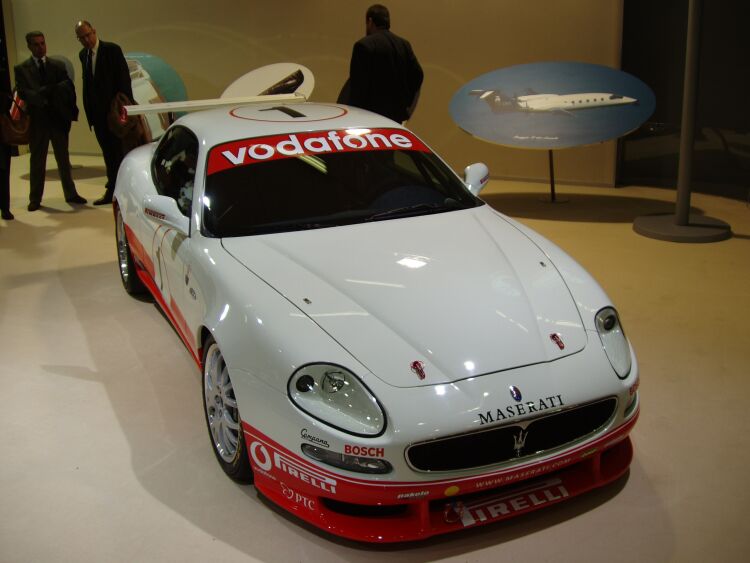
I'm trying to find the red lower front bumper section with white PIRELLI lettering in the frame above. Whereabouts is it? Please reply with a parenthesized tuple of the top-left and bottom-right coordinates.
(243, 412, 638, 543)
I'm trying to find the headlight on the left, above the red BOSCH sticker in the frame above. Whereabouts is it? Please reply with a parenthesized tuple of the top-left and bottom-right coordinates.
(288, 364, 385, 436)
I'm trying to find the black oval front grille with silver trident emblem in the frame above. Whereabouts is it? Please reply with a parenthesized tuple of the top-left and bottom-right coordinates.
(406, 397, 617, 471)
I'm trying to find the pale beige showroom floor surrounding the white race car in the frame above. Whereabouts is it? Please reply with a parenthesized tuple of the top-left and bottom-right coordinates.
(0, 152, 750, 562)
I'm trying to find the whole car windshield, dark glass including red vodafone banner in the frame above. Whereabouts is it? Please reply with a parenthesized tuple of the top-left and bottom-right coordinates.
(203, 129, 482, 237)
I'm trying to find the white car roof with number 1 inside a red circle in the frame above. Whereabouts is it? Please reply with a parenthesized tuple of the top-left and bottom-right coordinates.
(177, 102, 403, 147)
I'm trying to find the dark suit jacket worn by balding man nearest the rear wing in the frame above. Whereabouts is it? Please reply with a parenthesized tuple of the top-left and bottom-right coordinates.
(78, 40, 133, 127)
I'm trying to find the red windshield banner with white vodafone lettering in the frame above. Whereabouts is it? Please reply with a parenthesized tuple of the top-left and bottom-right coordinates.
(208, 129, 429, 175)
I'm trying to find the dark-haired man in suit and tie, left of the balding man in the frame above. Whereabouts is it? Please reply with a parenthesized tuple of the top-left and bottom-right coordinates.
(15, 31, 86, 211)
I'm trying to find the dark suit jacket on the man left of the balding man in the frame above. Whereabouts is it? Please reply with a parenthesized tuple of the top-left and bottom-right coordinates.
(14, 57, 78, 131)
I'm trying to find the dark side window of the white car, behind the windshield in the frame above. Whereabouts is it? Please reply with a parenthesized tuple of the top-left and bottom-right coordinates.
(151, 125, 198, 216)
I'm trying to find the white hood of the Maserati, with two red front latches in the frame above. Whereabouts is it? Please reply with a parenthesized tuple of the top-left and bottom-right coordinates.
(222, 205, 586, 387)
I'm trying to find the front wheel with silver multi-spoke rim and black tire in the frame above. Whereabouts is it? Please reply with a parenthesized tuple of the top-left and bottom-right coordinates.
(203, 337, 253, 483)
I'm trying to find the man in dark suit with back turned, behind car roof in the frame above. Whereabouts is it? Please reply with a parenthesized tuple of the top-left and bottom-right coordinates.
(339, 4, 424, 123)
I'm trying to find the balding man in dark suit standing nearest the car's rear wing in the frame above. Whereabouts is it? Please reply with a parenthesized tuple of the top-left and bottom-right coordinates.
(75, 20, 133, 205)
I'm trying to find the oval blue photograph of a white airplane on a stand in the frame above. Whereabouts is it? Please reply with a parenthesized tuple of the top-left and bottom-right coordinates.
(450, 62, 656, 150)
